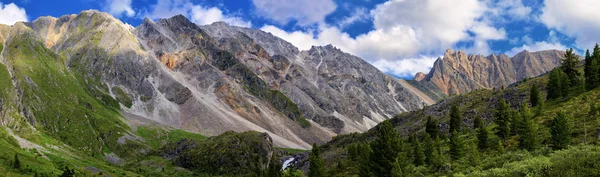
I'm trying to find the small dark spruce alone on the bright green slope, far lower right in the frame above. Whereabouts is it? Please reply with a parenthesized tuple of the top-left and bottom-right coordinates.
(550, 112, 571, 149)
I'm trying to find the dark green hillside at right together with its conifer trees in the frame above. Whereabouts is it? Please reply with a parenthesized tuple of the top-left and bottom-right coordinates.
(310, 46, 600, 176)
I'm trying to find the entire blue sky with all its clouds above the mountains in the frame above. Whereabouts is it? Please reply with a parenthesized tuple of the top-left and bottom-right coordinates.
(0, 0, 600, 78)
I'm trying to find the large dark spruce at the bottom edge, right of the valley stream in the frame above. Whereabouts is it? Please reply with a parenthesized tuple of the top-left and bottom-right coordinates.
(370, 120, 401, 177)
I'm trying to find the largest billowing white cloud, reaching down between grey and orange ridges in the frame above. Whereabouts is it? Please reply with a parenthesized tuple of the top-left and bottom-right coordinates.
(262, 0, 506, 76)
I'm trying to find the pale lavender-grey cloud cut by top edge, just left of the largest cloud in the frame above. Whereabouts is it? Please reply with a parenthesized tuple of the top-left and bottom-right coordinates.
(252, 0, 337, 26)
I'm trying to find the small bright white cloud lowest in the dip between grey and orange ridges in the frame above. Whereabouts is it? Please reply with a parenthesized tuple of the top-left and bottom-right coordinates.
(373, 56, 438, 78)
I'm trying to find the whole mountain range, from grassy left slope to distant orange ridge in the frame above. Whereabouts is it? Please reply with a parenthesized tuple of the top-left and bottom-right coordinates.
(0, 10, 563, 152)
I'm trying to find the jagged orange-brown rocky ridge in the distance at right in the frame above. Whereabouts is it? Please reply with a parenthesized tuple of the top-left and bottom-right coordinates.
(414, 50, 564, 98)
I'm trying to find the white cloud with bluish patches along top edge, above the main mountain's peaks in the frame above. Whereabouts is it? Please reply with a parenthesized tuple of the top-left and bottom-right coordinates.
(141, 0, 252, 27)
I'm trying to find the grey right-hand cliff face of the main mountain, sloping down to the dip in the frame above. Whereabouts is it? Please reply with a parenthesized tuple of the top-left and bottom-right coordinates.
(201, 23, 430, 133)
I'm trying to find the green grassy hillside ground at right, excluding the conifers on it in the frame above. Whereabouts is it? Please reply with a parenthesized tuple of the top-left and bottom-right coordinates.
(308, 59, 600, 176)
